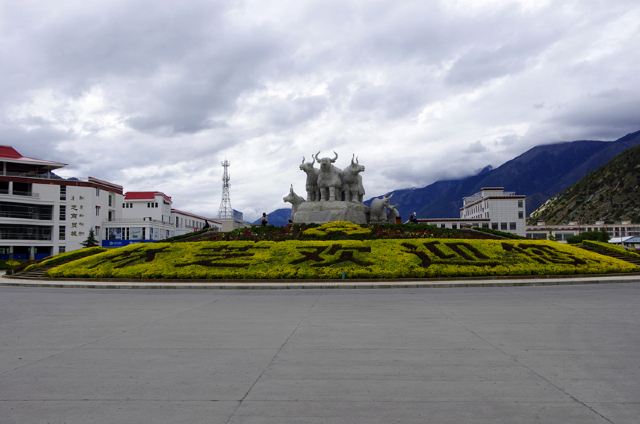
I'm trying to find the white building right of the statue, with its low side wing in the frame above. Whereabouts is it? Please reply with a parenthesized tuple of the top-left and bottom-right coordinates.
(418, 187, 526, 237)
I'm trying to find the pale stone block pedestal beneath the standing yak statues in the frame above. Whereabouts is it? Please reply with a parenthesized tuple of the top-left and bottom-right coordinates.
(293, 201, 369, 224)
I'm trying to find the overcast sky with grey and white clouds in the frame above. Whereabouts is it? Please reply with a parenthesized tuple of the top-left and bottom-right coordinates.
(0, 0, 640, 222)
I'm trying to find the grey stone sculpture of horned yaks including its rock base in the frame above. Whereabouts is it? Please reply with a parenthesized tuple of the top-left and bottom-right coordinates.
(283, 151, 399, 224)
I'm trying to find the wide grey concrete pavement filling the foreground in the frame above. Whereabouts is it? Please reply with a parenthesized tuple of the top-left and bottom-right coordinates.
(0, 283, 640, 424)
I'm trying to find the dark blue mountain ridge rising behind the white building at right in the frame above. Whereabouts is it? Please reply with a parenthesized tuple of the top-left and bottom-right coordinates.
(372, 131, 640, 219)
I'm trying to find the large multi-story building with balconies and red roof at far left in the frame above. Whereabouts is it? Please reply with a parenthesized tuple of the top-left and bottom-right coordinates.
(0, 146, 123, 259)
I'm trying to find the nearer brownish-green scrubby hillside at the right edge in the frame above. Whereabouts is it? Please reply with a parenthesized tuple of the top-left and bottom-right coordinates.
(531, 146, 640, 224)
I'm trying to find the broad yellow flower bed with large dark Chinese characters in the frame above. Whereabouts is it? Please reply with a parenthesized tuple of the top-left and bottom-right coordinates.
(48, 239, 639, 279)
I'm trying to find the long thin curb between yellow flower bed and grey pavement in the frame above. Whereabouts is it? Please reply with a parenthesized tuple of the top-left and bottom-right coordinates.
(0, 275, 640, 290)
